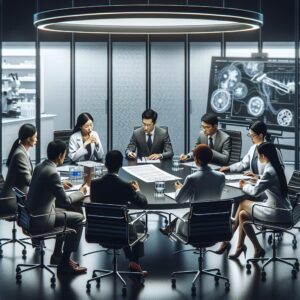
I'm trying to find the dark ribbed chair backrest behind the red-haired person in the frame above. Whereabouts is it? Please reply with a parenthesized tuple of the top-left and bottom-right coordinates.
(188, 199, 233, 247)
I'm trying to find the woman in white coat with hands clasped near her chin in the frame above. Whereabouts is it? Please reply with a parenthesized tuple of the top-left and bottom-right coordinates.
(69, 112, 104, 162)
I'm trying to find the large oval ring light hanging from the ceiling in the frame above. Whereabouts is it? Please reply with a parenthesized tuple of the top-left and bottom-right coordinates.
(34, 5, 263, 34)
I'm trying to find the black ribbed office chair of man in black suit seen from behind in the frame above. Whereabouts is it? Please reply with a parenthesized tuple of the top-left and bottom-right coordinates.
(85, 203, 148, 296)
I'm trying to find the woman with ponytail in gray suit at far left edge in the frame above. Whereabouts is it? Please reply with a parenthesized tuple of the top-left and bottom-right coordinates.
(0, 124, 37, 212)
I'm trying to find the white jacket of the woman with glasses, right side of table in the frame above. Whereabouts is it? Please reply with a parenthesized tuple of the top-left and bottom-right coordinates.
(229, 144, 284, 175)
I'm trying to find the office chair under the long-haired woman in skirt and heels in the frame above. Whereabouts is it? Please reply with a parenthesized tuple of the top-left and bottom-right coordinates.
(246, 194, 300, 281)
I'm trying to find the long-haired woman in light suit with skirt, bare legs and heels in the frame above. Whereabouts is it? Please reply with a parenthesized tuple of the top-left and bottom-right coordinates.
(222, 143, 291, 259)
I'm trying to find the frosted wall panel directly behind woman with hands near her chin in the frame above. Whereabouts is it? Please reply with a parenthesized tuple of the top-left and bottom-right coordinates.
(75, 42, 107, 152)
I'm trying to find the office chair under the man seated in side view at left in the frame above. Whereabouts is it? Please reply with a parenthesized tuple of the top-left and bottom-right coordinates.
(13, 188, 76, 287)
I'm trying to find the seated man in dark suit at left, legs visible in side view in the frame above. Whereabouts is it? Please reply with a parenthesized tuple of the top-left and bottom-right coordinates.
(26, 140, 86, 275)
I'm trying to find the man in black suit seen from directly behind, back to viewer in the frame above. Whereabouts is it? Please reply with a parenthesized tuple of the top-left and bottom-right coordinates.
(91, 150, 147, 275)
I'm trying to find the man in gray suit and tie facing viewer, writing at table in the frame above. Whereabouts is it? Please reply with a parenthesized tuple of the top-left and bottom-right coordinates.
(125, 109, 173, 160)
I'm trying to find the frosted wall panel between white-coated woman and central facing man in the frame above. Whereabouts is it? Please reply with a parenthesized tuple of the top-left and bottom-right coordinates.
(112, 42, 146, 153)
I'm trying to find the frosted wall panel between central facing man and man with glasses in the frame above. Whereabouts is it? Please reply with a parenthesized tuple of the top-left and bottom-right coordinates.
(151, 42, 184, 154)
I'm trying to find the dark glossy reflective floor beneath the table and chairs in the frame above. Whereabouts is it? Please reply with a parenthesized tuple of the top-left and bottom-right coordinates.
(0, 212, 300, 300)
